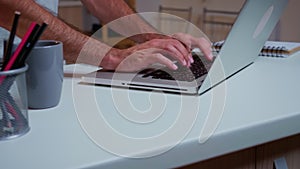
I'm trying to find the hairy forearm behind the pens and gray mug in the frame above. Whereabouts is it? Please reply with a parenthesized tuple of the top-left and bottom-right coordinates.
(0, 0, 115, 65)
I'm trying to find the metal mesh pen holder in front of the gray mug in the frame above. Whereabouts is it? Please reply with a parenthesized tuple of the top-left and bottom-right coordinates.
(0, 65, 29, 140)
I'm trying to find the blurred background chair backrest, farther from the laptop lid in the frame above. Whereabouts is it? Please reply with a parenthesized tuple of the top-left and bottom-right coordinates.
(159, 5, 192, 33)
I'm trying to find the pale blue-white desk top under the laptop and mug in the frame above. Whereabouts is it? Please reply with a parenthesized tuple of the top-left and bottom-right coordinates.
(0, 53, 300, 169)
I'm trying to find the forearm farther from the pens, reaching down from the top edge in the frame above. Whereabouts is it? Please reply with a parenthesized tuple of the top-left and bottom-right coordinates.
(81, 0, 168, 43)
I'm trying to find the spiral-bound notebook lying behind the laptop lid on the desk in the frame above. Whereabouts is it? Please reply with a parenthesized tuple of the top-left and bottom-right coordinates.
(213, 41, 300, 58)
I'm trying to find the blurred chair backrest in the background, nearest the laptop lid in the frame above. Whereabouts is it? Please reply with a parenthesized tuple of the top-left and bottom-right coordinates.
(202, 8, 239, 42)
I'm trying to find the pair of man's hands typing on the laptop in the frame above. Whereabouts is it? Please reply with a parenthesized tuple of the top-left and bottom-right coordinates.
(100, 34, 212, 72)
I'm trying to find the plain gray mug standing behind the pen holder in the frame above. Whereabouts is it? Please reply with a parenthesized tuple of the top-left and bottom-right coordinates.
(26, 40, 64, 109)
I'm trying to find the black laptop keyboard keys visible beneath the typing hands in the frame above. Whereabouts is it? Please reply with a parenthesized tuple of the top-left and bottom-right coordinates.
(142, 54, 210, 82)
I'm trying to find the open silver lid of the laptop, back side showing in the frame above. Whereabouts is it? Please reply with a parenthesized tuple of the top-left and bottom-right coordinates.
(199, 0, 288, 93)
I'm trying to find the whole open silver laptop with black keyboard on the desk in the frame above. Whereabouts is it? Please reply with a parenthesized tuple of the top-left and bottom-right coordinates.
(82, 0, 288, 95)
